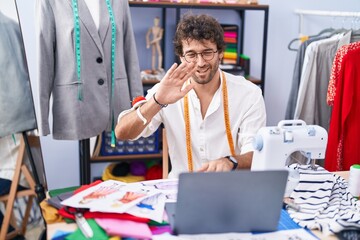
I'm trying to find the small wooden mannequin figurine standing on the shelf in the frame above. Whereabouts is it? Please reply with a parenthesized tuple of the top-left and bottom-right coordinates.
(142, 17, 164, 80)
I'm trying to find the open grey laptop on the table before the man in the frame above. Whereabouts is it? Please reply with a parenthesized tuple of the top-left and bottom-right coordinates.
(165, 170, 288, 234)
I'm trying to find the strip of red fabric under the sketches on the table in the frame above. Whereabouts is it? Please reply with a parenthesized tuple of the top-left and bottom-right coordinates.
(59, 208, 150, 223)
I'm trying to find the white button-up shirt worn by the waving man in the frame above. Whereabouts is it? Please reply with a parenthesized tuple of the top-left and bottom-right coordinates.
(138, 70, 266, 178)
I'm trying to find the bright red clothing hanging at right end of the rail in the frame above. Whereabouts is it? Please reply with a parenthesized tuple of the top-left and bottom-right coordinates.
(325, 44, 360, 171)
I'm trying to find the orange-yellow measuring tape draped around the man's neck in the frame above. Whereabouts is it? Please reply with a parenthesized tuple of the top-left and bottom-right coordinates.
(184, 71, 235, 172)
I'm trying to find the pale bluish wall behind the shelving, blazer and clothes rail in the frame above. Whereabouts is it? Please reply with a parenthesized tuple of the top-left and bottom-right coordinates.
(17, 0, 360, 189)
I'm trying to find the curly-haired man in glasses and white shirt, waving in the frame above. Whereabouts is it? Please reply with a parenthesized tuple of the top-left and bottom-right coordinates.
(115, 15, 266, 177)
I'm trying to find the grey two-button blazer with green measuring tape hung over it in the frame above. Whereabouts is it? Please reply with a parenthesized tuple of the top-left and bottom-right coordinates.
(36, 0, 143, 140)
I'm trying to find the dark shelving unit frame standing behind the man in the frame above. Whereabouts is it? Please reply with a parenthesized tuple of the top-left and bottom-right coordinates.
(81, 1, 269, 184)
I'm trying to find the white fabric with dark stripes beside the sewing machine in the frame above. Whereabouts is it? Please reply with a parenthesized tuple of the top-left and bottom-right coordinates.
(288, 164, 360, 235)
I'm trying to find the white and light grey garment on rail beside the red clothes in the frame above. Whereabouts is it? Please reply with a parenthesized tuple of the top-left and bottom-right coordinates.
(294, 34, 350, 129)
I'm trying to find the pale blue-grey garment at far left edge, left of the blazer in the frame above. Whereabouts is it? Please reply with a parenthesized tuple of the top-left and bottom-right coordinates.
(0, 12, 36, 137)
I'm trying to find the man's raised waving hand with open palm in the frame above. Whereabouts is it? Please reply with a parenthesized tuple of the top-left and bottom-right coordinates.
(156, 62, 196, 104)
